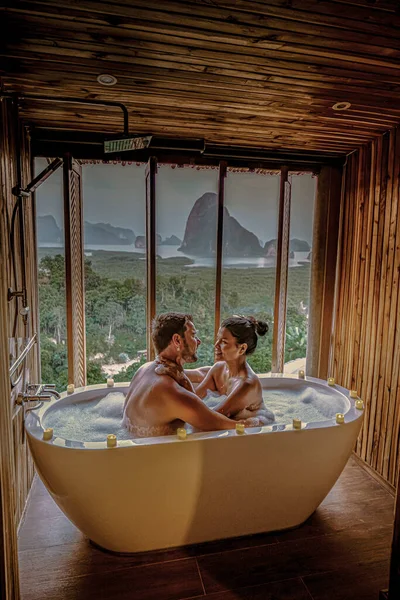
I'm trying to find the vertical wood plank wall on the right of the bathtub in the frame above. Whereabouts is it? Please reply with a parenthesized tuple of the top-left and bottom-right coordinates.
(332, 128, 400, 485)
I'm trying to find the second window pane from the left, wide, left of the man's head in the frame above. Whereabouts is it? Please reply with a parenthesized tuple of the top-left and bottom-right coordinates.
(82, 164, 146, 385)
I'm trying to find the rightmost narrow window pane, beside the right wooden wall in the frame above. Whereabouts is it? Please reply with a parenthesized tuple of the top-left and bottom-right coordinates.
(284, 173, 317, 373)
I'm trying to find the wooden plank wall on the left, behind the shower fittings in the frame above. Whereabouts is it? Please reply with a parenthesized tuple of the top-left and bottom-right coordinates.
(0, 100, 39, 600)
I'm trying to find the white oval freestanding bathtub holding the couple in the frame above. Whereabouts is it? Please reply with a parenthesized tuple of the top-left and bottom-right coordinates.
(25, 376, 363, 552)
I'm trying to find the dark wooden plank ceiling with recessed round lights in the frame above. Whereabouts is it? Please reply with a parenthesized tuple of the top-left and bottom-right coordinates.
(0, 0, 400, 155)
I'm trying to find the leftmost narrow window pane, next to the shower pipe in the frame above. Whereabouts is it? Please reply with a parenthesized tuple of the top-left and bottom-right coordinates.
(35, 158, 68, 391)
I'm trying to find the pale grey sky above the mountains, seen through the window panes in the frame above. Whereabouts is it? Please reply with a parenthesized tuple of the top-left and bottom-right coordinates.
(36, 159, 316, 245)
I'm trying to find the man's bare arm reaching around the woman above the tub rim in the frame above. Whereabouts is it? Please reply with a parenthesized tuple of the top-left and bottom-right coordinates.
(163, 380, 236, 431)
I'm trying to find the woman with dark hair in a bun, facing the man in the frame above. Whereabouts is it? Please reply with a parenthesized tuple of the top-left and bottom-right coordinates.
(196, 316, 275, 427)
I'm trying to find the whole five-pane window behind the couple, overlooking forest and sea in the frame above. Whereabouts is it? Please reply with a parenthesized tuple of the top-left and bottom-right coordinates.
(36, 159, 316, 389)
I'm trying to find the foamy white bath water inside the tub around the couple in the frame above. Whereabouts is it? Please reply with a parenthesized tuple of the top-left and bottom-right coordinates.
(43, 386, 347, 442)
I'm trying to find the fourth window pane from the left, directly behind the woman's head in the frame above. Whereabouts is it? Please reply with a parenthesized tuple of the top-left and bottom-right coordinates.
(221, 169, 280, 373)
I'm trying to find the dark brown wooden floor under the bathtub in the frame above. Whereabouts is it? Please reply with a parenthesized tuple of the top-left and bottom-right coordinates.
(19, 459, 394, 600)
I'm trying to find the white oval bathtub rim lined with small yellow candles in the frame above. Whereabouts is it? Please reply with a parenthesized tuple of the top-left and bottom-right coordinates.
(25, 373, 365, 450)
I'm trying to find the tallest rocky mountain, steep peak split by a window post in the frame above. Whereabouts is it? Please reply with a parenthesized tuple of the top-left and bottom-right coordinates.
(178, 192, 263, 257)
